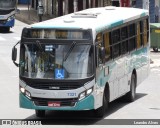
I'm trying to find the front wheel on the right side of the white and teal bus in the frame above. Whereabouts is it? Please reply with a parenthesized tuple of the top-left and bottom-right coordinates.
(95, 89, 109, 118)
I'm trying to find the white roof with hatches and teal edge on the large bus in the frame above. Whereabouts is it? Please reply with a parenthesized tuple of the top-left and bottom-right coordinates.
(31, 6, 149, 32)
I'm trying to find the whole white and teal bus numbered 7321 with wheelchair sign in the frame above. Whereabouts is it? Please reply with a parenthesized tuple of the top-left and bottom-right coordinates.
(12, 7, 150, 117)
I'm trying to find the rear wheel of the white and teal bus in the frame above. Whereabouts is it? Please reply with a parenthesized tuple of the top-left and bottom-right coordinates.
(125, 74, 136, 102)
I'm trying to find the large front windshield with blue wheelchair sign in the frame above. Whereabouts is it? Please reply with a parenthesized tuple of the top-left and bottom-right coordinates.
(20, 43, 93, 79)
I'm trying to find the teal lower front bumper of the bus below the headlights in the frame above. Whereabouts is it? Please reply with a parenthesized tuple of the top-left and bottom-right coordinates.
(19, 93, 94, 111)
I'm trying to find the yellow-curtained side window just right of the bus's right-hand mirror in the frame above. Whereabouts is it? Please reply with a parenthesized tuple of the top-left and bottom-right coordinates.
(103, 32, 111, 61)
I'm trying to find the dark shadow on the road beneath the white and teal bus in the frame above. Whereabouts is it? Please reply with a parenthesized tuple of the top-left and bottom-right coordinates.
(24, 93, 147, 125)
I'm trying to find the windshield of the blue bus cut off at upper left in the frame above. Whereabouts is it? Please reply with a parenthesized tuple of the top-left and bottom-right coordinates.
(0, 0, 16, 10)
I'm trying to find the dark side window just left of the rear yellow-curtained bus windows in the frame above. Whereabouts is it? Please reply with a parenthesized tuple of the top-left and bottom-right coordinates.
(128, 24, 136, 51)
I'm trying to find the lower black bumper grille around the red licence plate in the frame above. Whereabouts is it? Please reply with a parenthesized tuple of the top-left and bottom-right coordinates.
(32, 97, 78, 107)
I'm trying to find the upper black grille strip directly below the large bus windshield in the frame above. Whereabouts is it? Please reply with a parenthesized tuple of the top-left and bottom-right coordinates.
(28, 82, 83, 90)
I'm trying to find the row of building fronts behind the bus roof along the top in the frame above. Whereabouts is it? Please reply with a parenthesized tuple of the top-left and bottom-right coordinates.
(30, 0, 160, 23)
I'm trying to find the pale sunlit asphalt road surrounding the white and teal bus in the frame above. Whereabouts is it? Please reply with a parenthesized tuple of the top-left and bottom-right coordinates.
(0, 21, 160, 128)
